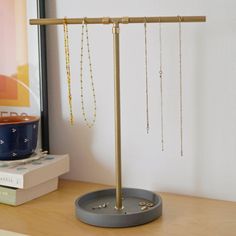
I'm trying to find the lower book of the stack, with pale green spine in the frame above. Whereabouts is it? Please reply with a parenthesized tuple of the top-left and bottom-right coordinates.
(0, 177, 58, 206)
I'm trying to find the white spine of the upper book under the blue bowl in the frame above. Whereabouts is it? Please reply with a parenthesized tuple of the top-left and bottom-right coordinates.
(0, 172, 23, 188)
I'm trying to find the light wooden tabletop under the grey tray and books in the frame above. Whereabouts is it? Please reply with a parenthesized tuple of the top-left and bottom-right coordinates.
(0, 180, 236, 236)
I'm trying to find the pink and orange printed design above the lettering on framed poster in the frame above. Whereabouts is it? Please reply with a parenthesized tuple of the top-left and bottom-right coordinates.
(0, 0, 30, 107)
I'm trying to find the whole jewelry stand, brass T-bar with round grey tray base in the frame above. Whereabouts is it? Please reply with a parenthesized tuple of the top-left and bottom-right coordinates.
(30, 16, 206, 227)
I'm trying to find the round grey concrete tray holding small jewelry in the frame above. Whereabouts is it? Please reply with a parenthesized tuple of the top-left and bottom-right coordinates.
(75, 188, 162, 227)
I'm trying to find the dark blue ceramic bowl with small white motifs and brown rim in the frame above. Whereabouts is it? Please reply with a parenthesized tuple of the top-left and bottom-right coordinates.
(0, 116, 39, 161)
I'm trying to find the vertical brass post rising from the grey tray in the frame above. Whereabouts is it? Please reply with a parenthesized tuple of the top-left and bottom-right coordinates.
(112, 23, 122, 210)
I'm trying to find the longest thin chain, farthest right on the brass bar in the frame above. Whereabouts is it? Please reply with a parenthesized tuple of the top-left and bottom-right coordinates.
(179, 16, 184, 156)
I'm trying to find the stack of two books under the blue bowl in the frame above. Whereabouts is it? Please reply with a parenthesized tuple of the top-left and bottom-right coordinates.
(0, 155, 69, 206)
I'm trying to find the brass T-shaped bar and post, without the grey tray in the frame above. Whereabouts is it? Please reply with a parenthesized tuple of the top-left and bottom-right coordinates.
(30, 16, 206, 210)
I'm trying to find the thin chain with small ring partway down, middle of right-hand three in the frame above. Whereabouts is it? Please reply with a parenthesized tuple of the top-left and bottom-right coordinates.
(159, 22, 164, 151)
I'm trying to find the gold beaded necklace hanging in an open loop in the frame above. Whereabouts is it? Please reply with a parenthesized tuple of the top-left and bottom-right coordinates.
(80, 20, 97, 128)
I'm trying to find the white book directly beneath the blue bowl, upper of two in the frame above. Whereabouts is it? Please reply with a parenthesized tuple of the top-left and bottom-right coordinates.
(0, 154, 69, 189)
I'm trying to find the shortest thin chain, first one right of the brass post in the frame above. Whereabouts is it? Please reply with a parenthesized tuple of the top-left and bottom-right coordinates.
(144, 18, 150, 133)
